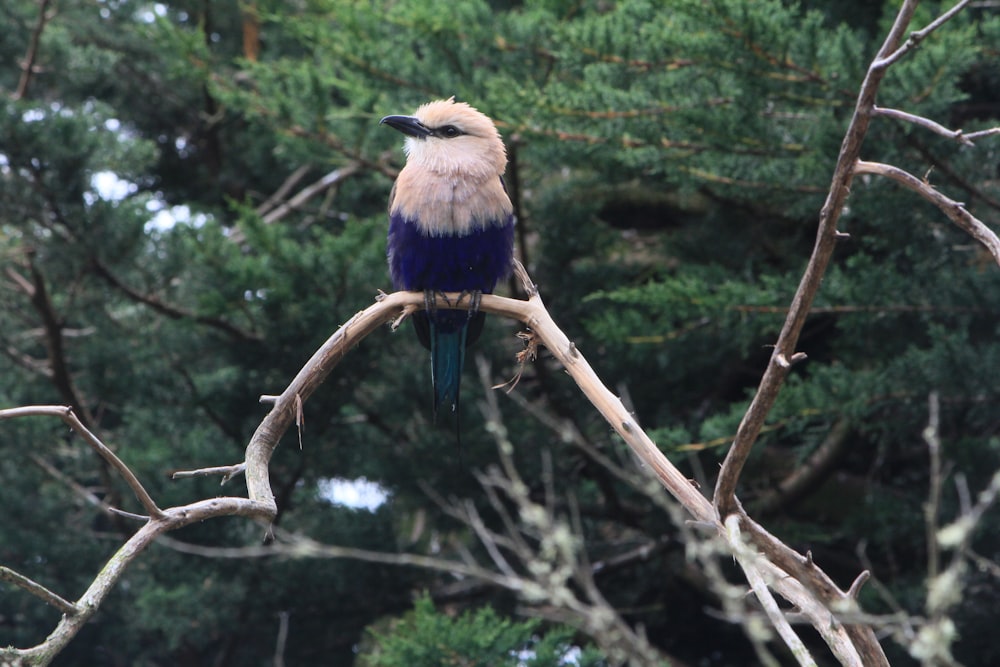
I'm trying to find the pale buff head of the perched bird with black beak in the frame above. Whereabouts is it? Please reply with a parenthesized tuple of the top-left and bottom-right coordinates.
(379, 98, 507, 178)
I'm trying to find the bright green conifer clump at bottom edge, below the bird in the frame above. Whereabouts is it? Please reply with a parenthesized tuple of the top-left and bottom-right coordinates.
(358, 593, 607, 667)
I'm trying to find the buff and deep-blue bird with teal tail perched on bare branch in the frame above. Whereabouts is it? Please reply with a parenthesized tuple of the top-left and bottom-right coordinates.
(379, 97, 515, 428)
